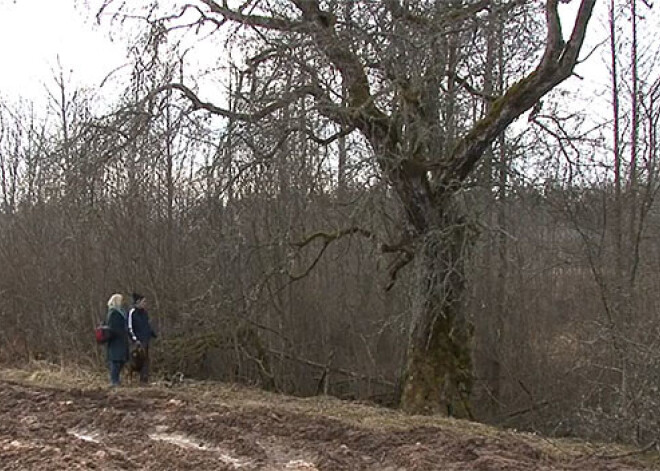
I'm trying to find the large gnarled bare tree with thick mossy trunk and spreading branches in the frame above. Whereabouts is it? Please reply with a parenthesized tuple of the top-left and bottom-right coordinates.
(129, 0, 596, 416)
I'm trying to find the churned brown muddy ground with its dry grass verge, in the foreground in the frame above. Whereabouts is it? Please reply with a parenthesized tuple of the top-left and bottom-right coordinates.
(0, 378, 651, 471)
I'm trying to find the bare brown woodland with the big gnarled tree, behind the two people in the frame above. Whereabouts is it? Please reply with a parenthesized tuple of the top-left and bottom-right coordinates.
(0, 0, 660, 445)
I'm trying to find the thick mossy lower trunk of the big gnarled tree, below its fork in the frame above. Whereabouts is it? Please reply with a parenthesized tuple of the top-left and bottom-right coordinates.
(401, 216, 472, 417)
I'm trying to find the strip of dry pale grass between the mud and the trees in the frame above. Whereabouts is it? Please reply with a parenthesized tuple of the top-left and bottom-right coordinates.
(0, 361, 660, 469)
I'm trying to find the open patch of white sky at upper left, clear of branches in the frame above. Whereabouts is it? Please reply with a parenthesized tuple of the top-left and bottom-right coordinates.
(0, 0, 126, 101)
